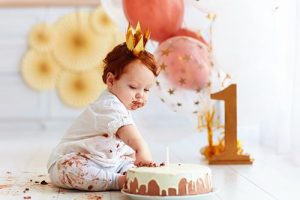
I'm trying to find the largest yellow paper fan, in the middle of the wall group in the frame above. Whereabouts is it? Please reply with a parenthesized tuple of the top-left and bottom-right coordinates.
(53, 12, 110, 71)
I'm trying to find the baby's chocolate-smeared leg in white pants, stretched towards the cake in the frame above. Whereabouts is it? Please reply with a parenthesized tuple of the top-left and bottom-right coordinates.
(50, 154, 122, 191)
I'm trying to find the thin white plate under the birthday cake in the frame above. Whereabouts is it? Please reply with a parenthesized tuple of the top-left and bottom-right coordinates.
(121, 189, 216, 200)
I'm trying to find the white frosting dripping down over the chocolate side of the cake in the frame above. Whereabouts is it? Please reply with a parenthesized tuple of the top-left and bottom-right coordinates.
(127, 164, 212, 195)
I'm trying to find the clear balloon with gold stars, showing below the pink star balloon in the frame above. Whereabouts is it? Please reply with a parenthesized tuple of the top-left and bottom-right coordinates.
(155, 57, 232, 116)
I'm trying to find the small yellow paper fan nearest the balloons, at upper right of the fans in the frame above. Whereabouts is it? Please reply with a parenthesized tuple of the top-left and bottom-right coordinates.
(91, 6, 118, 35)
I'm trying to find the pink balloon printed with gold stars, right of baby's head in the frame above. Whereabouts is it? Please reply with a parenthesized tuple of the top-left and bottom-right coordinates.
(154, 36, 211, 90)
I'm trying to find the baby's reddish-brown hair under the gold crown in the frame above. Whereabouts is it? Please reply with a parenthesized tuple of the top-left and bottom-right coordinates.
(102, 42, 160, 83)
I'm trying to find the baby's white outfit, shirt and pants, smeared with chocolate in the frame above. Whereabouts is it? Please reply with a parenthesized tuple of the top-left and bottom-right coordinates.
(47, 90, 134, 191)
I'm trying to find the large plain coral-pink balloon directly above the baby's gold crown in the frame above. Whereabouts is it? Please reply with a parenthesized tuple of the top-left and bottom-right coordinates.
(123, 0, 184, 41)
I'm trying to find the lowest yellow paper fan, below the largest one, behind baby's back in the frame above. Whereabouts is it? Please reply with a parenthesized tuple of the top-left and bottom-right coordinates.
(57, 69, 106, 108)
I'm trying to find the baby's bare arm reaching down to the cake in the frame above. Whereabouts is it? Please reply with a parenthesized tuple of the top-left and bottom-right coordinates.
(117, 125, 153, 165)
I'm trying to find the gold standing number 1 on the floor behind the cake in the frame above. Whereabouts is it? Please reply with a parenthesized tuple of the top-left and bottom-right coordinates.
(208, 84, 253, 164)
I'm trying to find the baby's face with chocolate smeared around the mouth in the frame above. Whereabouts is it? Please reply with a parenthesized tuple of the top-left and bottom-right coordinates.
(109, 60, 155, 110)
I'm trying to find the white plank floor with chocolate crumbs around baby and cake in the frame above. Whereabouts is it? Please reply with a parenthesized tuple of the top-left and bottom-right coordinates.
(0, 128, 300, 200)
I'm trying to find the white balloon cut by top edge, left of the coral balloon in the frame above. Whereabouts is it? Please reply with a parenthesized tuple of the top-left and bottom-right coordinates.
(100, 0, 128, 32)
